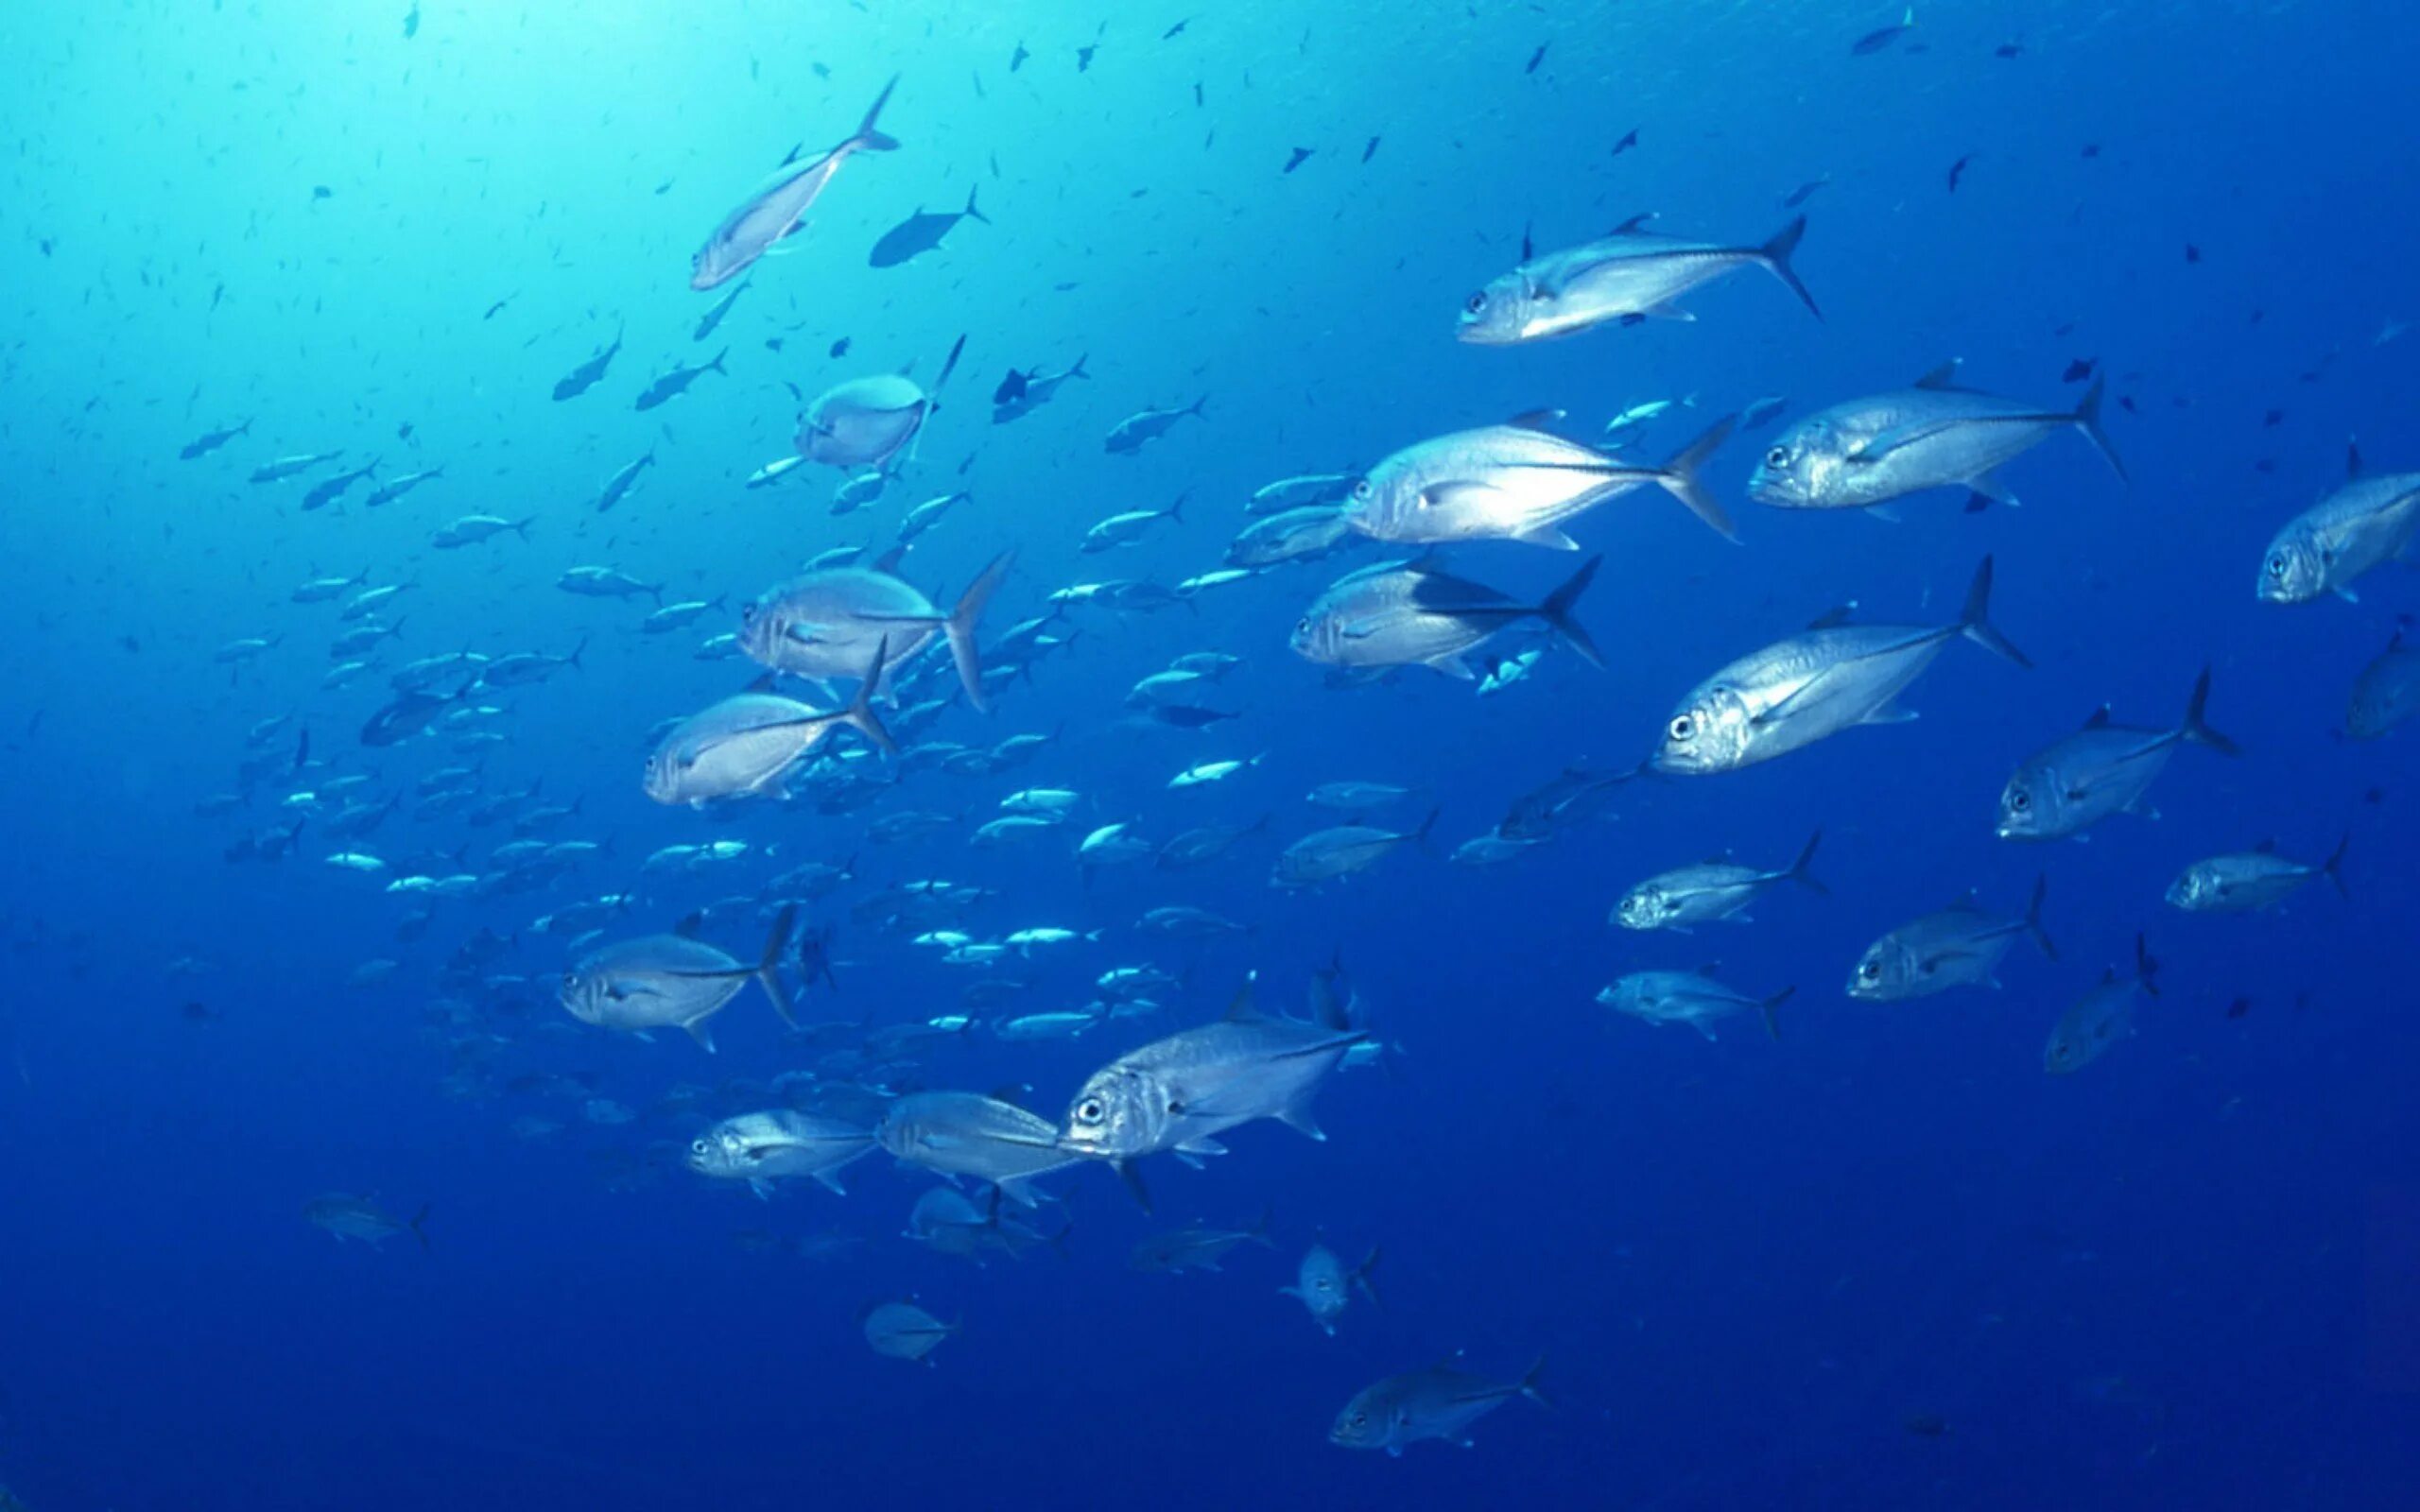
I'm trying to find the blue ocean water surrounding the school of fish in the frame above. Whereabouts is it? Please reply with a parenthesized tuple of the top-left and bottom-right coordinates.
(0, 0, 2420, 1512)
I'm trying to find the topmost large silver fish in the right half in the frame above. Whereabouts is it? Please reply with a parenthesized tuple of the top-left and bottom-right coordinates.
(1455, 215, 1823, 346)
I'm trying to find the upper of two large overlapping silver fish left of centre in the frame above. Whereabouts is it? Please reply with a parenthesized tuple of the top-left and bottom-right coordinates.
(740, 547, 1016, 712)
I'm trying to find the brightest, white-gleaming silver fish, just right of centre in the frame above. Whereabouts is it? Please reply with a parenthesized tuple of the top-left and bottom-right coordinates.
(1345, 411, 1736, 552)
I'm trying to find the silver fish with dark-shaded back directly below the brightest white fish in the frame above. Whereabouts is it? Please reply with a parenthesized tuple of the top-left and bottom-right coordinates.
(1288, 557, 1604, 682)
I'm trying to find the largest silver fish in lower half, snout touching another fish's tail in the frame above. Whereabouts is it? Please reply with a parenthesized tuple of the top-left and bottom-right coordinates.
(1060, 977, 1370, 1171)
